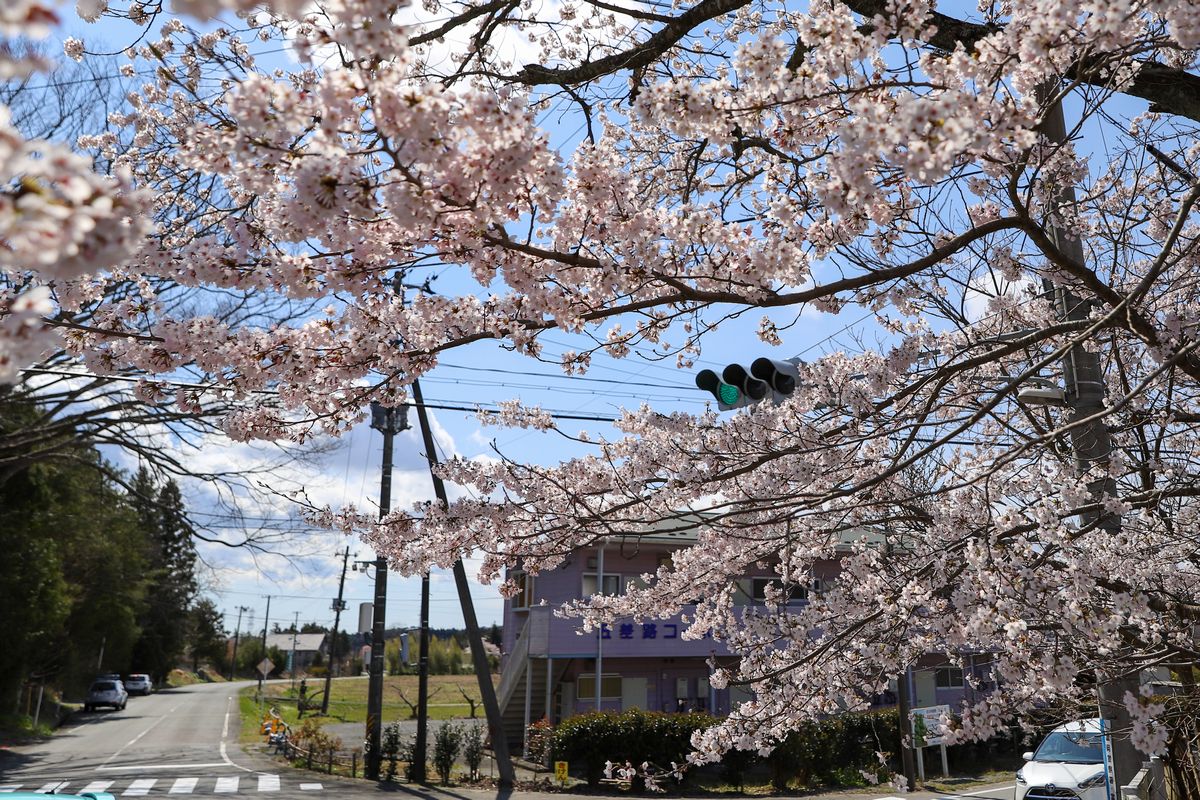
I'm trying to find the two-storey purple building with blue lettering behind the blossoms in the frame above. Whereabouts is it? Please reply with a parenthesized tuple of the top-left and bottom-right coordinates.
(498, 531, 989, 748)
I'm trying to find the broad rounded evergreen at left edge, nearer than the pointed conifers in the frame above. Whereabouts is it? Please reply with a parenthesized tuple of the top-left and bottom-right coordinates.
(0, 393, 146, 711)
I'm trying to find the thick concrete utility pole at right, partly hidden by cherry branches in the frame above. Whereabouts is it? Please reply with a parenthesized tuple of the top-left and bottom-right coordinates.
(1042, 94, 1141, 788)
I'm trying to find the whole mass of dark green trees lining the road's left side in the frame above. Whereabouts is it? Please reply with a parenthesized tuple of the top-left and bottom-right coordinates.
(0, 393, 226, 712)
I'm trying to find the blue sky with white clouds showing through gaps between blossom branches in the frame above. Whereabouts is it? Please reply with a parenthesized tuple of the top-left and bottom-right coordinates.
(30, 0, 1161, 630)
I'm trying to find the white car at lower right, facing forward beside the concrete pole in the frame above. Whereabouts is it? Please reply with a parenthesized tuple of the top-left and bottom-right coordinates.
(1015, 720, 1109, 800)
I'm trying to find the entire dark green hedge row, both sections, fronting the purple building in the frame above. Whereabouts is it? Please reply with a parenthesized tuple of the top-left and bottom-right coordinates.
(551, 709, 900, 790)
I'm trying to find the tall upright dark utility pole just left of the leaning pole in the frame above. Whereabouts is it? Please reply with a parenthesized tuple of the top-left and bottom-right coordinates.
(364, 403, 408, 781)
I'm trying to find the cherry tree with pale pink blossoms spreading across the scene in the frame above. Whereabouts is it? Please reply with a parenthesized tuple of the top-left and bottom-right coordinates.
(7, 0, 1200, 793)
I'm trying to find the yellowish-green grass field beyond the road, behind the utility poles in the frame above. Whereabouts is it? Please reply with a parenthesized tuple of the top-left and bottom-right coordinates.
(240, 675, 499, 740)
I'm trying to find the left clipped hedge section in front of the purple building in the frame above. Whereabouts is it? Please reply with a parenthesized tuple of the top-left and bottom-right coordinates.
(552, 709, 716, 786)
